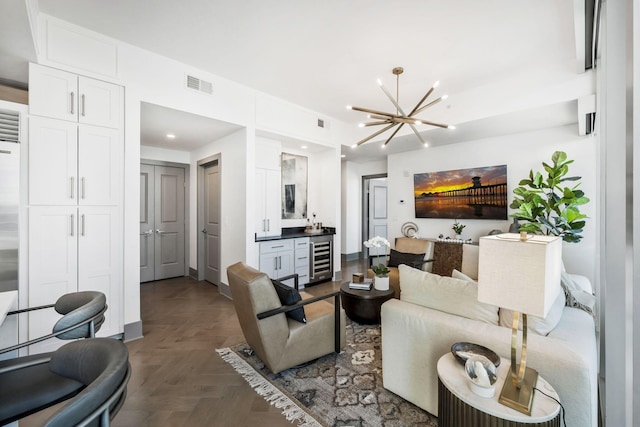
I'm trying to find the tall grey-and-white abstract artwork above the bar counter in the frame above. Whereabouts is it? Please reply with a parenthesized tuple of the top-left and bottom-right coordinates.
(281, 153, 307, 219)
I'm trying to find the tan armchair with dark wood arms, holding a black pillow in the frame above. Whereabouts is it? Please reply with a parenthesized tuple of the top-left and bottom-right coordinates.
(227, 262, 346, 373)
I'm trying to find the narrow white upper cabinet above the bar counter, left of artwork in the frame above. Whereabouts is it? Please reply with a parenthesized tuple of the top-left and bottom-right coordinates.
(255, 169, 282, 237)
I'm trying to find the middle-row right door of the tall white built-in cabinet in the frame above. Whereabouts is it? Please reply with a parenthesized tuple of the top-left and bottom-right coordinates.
(77, 125, 124, 205)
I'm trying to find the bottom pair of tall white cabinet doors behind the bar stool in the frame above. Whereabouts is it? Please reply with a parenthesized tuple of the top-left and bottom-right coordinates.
(28, 206, 122, 353)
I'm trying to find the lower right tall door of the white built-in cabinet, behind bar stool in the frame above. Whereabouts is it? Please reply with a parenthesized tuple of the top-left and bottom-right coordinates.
(78, 206, 122, 336)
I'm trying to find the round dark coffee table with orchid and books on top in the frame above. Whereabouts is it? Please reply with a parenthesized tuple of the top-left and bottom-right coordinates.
(340, 282, 394, 324)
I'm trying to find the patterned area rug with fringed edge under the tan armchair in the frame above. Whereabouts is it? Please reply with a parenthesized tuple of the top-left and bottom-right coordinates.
(216, 322, 438, 427)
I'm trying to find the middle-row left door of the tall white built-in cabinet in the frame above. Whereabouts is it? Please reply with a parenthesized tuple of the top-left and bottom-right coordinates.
(29, 117, 78, 205)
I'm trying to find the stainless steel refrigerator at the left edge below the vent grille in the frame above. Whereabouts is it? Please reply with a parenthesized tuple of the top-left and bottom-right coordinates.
(0, 141, 20, 292)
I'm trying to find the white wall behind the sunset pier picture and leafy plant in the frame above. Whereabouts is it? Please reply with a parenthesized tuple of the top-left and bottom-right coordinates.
(388, 125, 599, 283)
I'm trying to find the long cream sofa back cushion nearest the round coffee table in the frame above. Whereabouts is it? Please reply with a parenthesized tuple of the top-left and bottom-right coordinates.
(398, 265, 498, 325)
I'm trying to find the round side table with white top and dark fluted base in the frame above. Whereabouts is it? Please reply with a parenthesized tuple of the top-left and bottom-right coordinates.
(438, 353, 560, 427)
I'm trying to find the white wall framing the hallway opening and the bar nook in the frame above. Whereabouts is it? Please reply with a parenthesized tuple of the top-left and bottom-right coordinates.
(30, 14, 349, 332)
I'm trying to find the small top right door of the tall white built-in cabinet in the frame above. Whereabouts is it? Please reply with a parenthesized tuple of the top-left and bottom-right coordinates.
(78, 76, 122, 128)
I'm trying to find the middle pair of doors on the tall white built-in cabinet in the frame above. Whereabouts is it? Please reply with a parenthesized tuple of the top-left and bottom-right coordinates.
(29, 117, 124, 205)
